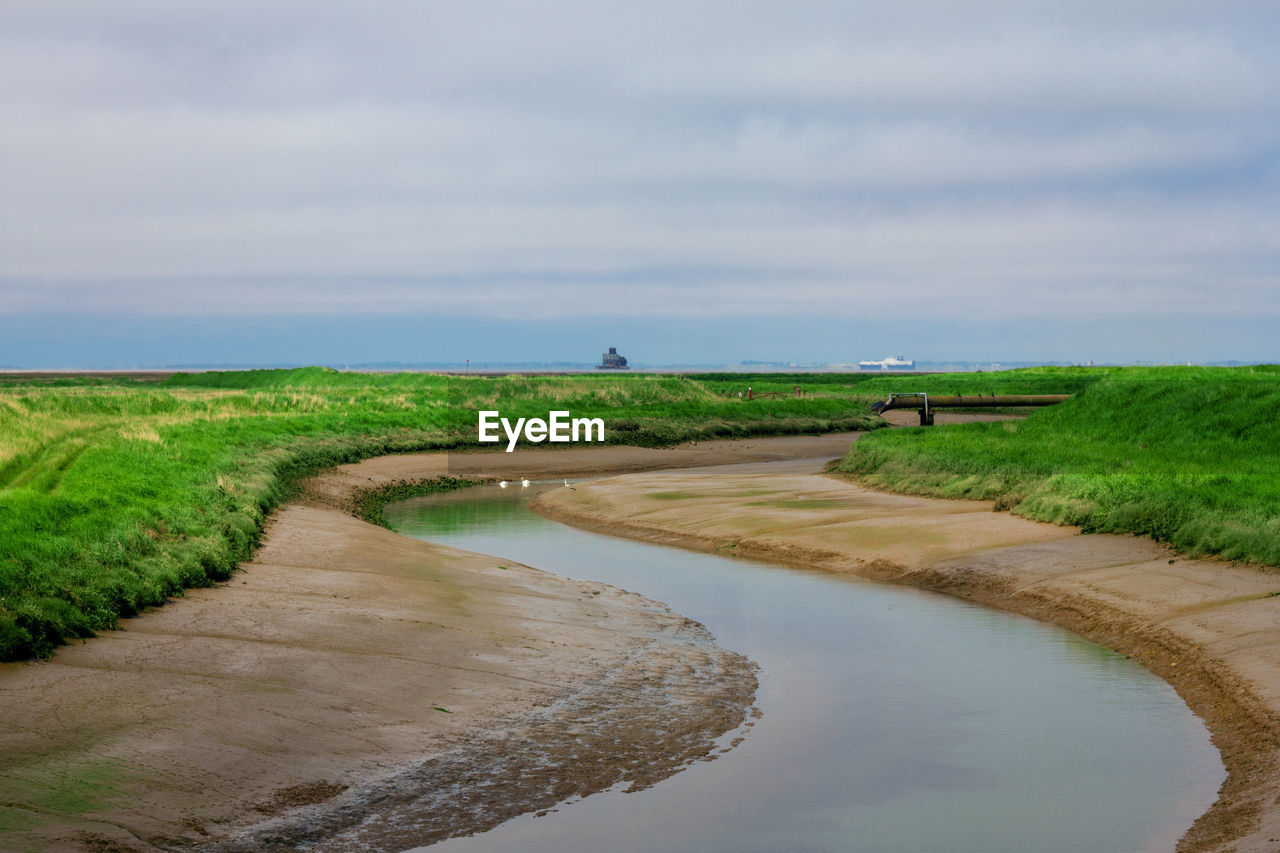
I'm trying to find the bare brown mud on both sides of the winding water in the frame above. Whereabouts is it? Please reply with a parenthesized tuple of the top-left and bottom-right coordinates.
(0, 435, 1280, 853)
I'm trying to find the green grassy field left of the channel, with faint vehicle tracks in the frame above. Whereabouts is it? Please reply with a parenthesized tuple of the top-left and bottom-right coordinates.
(0, 368, 878, 660)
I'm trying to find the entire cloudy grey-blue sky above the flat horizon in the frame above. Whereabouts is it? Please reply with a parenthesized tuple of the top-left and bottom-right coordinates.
(0, 0, 1280, 368)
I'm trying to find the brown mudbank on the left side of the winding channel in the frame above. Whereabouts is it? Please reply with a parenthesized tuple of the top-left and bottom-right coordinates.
(0, 435, 850, 850)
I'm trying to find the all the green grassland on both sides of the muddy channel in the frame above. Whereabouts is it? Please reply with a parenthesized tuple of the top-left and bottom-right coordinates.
(0, 368, 1280, 660)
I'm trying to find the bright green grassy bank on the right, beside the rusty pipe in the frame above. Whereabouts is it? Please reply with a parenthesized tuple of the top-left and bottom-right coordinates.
(840, 366, 1280, 566)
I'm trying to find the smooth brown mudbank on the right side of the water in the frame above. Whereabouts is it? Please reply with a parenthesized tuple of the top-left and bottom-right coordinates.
(532, 462, 1280, 853)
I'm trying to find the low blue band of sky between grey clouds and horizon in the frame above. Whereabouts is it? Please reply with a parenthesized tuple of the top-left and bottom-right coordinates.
(0, 313, 1280, 370)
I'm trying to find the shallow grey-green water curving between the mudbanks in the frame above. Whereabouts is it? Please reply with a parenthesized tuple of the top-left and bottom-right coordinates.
(387, 484, 1225, 853)
